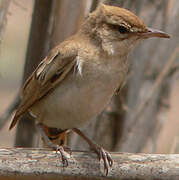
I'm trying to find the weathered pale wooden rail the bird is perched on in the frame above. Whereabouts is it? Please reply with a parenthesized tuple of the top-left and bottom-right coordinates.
(0, 148, 179, 180)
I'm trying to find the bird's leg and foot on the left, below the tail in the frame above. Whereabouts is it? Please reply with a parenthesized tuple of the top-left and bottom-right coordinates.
(37, 123, 68, 166)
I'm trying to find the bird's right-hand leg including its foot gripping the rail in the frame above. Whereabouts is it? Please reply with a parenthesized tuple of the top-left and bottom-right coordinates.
(72, 128, 113, 175)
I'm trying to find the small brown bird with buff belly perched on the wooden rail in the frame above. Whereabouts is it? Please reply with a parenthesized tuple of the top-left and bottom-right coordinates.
(9, 3, 170, 175)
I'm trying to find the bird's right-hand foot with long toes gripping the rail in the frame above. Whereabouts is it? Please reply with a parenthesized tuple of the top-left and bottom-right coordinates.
(92, 144, 113, 176)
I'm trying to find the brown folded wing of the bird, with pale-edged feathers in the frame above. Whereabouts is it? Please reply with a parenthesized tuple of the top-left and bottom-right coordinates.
(9, 47, 76, 129)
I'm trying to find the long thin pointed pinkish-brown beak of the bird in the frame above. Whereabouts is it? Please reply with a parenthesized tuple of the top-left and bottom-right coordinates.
(140, 28, 170, 38)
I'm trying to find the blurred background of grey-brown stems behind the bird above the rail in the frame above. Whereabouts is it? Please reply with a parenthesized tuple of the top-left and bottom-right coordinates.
(0, 0, 179, 153)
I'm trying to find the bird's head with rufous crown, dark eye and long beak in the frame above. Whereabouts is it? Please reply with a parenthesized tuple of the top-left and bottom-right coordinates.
(84, 4, 170, 55)
